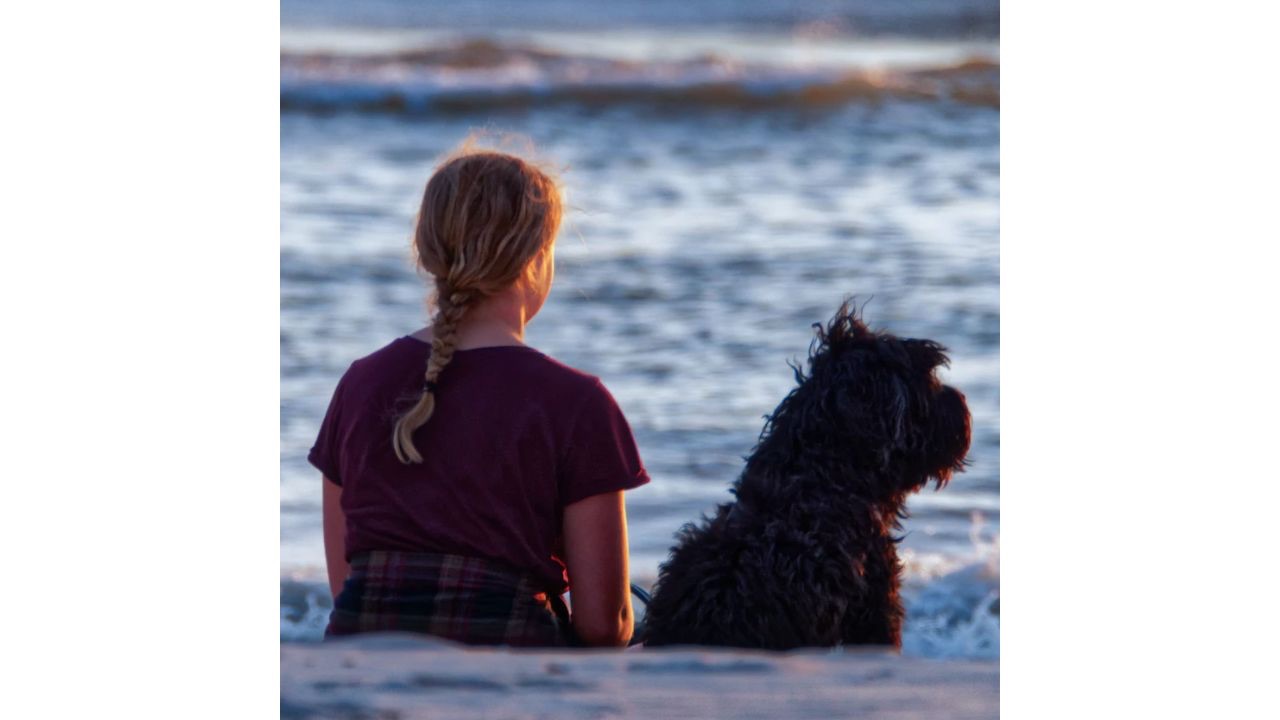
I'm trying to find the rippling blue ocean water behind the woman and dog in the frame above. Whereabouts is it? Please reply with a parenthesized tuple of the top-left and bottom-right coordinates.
(280, 0, 1000, 657)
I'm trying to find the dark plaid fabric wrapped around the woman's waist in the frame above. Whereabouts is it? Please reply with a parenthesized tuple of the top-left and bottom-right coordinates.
(325, 551, 566, 647)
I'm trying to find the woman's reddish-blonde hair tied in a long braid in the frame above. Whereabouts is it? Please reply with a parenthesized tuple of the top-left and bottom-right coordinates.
(392, 141, 563, 464)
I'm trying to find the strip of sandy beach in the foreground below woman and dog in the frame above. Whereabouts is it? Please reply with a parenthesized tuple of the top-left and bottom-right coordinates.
(280, 633, 1000, 720)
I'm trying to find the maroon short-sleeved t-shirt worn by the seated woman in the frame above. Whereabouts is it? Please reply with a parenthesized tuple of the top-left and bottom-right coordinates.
(307, 337, 649, 592)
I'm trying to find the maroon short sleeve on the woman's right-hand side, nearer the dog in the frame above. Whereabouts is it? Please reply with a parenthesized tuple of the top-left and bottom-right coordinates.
(559, 380, 649, 506)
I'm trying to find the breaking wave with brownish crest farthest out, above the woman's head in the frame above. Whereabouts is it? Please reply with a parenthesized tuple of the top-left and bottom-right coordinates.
(280, 40, 1000, 113)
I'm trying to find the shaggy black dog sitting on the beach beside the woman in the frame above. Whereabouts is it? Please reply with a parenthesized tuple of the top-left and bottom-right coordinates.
(643, 302, 969, 650)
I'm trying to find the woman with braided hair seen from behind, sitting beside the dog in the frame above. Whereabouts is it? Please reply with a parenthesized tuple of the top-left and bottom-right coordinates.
(308, 144, 649, 646)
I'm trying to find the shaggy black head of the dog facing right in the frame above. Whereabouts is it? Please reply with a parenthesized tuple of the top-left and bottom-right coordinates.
(762, 302, 970, 497)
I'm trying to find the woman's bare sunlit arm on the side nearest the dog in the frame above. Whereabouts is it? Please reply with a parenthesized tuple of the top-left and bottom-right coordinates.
(564, 491, 632, 647)
